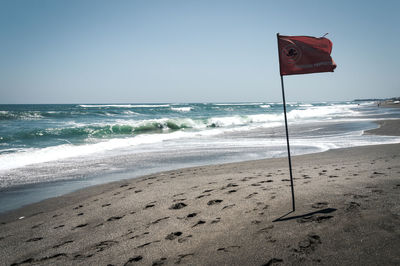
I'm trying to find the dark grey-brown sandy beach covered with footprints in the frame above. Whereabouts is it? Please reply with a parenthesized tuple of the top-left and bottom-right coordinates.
(0, 120, 400, 265)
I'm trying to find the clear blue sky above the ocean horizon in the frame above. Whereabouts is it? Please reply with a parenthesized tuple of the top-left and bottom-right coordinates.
(0, 0, 400, 103)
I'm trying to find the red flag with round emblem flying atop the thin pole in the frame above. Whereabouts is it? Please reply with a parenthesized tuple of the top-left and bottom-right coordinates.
(278, 34, 336, 76)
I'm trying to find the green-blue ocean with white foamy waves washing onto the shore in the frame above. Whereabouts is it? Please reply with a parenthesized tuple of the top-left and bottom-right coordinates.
(0, 101, 400, 212)
